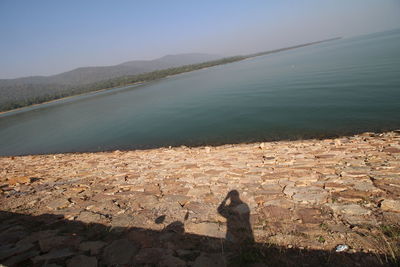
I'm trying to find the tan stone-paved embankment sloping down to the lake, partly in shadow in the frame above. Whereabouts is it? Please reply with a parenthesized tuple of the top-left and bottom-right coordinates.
(0, 131, 400, 267)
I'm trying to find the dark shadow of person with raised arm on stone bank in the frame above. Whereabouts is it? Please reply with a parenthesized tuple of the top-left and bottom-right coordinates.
(218, 190, 254, 247)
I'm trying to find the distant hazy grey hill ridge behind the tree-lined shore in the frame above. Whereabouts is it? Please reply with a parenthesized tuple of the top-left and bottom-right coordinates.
(0, 53, 222, 88)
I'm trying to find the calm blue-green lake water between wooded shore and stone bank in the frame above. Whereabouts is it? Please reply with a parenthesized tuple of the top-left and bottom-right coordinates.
(0, 30, 400, 155)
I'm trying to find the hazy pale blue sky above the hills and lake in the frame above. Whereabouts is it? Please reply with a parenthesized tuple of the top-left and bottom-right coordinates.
(0, 0, 400, 78)
